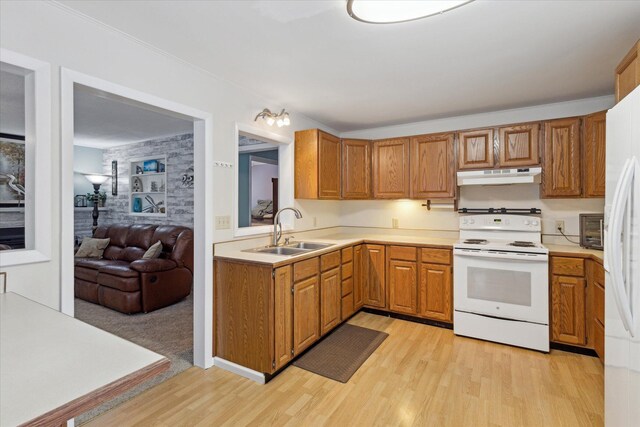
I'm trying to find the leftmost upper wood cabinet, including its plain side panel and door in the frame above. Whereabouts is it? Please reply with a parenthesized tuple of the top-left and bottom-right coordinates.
(294, 129, 342, 199)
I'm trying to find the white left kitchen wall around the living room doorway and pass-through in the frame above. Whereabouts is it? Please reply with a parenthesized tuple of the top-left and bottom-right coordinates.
(0, 1, 339, 308)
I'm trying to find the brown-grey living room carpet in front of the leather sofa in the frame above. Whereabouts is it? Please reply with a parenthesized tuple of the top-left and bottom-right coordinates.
(75, 293, 193, 425)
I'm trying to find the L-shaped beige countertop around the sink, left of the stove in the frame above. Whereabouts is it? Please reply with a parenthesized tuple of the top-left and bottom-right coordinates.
(215, 233, 458, 267)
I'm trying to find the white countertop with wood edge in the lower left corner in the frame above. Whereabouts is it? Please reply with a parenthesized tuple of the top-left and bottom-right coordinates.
(0, 292, 168, 426)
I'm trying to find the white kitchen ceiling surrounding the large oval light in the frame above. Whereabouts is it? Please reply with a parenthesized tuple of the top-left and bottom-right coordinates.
(40, 0, 640, 131)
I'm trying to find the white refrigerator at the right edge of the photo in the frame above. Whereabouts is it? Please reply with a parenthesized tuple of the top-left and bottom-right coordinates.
(604, 87, 640, 427)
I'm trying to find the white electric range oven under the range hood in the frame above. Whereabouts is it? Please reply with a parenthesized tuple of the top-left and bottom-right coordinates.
(453, 214, 549, 352)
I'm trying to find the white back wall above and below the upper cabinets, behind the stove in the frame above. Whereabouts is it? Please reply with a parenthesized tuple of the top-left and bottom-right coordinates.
(340, 96, 614, 243)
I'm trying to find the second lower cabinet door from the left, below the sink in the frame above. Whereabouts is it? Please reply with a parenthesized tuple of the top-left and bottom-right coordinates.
(293, 276, 320, 355)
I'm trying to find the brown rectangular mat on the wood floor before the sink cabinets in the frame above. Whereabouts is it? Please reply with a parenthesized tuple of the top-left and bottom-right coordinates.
(293, 323, 389, 383)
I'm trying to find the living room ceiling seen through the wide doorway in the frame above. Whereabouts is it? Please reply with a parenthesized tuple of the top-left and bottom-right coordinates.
(73, 85, 193, 149)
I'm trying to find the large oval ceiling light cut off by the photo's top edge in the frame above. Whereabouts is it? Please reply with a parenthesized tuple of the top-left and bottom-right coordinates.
(347, 0, 473, 24)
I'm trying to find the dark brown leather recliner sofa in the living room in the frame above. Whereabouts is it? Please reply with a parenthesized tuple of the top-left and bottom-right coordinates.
(74, 225, 193, 313)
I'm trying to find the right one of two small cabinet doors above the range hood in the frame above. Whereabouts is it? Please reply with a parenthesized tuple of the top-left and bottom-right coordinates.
(498, 123, 540, 167)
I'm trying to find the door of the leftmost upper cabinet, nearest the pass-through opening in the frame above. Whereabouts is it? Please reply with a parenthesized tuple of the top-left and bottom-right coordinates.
(318, 131, 342, 199)
